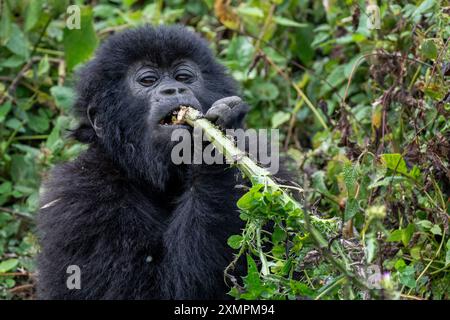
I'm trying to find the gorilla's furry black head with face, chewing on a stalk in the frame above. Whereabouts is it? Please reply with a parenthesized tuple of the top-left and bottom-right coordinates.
(73, 26, 237, 190)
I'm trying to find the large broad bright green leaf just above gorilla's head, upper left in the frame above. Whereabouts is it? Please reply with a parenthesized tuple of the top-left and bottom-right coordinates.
(63, 7, 98, 70)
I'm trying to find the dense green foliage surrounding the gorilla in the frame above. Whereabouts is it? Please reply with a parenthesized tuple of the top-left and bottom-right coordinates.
(0, 0, 450, 299)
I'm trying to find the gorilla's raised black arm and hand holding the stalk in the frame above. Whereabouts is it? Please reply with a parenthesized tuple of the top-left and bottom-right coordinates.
(161, 96, 248, 299)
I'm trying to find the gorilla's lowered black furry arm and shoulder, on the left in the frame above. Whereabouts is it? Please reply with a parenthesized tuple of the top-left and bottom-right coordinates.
(38, 150, 166, 299)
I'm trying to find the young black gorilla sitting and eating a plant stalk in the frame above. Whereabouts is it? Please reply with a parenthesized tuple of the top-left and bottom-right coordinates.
(38, 27, 247, 299)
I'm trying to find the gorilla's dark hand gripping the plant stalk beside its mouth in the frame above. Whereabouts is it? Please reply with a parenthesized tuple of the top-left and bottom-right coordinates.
(205, 96, 248, 129)
